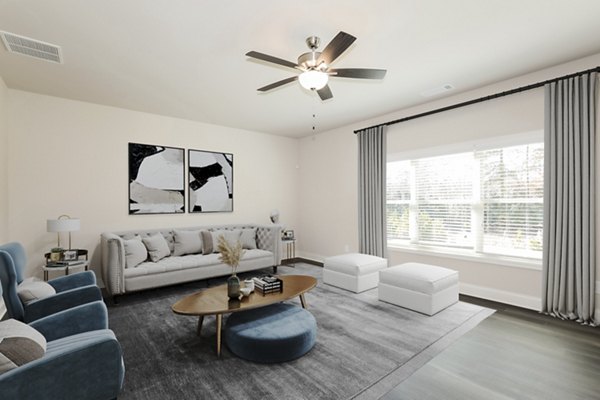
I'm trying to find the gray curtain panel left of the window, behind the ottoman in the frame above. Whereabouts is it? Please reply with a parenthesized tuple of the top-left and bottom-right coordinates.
(356, 126, 387, 258)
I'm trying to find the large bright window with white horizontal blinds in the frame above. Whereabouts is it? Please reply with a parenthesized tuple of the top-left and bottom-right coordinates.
(387, 143, 544, 258)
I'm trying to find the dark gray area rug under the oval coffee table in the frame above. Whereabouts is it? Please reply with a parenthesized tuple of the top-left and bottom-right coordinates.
(109, 263, 491, 400)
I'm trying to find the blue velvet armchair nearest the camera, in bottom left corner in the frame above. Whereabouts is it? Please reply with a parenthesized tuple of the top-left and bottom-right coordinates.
(0, 292, 125, 400)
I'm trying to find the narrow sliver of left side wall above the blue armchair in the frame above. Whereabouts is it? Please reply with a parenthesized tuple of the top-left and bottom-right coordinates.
(0, 77, 8, 243)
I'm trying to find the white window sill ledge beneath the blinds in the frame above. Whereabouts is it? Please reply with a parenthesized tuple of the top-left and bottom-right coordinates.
(388, 244, 542, 271)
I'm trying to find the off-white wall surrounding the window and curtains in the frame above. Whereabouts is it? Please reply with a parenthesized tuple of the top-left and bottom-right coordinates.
(297, 54, 600, 312)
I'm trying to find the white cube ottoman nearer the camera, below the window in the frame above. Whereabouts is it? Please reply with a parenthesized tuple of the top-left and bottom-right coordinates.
(379, 263, 458, 315)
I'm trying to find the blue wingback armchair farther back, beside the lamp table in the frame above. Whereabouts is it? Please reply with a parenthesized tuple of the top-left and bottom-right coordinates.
(0, 242, 102, 323)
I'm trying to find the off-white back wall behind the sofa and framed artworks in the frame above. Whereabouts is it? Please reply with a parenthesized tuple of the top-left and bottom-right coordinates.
(8, 89, 298, 282)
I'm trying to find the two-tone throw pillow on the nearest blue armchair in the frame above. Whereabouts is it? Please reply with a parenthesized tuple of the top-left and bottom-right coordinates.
(0, 319, 46, 374)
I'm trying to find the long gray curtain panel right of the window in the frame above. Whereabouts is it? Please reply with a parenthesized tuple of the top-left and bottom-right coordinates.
(542, 72, 597, 325)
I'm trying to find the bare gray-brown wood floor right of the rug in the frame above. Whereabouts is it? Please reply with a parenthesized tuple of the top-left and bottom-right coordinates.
(383, 297, 600, 400)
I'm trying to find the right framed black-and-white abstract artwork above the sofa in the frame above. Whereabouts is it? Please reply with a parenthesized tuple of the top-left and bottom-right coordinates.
(188, 150, 233, 212)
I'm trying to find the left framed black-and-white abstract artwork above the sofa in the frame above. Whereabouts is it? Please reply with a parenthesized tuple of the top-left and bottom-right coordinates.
(129, 143, 185, 214)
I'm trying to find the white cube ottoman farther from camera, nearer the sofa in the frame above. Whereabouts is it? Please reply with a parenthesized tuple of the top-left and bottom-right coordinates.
(323, 253, 387, 293)
